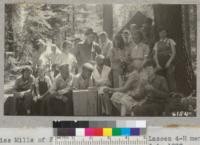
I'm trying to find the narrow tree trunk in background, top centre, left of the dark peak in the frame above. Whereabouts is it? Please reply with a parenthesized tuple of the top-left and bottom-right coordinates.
(103, 4, 113, 39)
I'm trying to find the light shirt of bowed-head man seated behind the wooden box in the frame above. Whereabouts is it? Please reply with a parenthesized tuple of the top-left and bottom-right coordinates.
(73, 74, 93, 89)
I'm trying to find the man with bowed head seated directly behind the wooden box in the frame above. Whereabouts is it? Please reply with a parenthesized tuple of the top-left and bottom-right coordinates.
(73, 63, 94, 90)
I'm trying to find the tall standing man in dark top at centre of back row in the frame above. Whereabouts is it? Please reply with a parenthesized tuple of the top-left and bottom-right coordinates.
(76, 28, 101, 66)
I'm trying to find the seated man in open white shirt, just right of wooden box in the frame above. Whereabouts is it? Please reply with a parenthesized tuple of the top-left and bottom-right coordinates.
(92, 55, 111, 115)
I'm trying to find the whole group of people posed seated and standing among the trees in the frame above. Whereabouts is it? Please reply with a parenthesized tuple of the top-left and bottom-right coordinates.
(7, 19, 180, 116)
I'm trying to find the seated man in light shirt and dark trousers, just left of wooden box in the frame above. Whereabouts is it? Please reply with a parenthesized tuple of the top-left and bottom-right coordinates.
(48, 64, 73, 115)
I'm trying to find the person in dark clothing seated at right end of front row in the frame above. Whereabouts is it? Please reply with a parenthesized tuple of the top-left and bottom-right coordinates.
(132, 62, 169, 116)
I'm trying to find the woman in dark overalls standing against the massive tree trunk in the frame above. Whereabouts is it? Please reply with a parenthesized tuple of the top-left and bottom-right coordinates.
(154, 28, 176, 91)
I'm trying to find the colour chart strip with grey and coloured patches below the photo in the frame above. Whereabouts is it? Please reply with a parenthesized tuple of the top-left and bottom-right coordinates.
(53, 121, 146, 137)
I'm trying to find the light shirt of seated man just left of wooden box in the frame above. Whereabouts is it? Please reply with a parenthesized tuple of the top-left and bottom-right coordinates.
(50, 74, 73, 93)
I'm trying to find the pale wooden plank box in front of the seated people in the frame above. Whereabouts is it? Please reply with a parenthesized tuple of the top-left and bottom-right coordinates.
(73, 90, 97, 116)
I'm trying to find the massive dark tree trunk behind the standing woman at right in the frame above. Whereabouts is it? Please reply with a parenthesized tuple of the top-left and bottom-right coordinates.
(154, 5, 196, 95)
